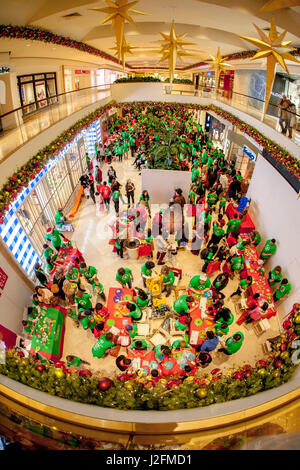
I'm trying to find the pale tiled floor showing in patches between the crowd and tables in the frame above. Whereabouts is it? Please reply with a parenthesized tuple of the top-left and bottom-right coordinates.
(63, 154, 278, 376)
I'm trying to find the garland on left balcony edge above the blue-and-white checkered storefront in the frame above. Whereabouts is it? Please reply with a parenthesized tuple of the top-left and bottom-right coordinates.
(0, 102, 114, 224)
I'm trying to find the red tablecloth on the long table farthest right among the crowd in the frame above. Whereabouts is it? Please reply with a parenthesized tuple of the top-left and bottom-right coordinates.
(237, 245, 276, 325)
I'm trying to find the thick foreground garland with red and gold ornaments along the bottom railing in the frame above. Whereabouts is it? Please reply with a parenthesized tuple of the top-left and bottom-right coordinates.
(0, 304, 300, 411)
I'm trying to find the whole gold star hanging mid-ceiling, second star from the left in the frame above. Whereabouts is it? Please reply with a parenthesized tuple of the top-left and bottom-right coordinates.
(155, 21, 195, 83)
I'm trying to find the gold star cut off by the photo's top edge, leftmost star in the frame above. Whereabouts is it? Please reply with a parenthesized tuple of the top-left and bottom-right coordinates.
(90, 0, 146, 61)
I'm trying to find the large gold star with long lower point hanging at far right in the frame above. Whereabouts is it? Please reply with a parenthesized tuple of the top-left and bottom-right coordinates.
(239, 18, 299, 115)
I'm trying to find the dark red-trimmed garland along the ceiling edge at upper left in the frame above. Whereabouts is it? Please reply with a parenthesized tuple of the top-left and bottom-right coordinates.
(0, 24, 131, 68)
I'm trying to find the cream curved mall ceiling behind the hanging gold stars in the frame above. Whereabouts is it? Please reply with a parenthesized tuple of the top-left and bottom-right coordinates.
(0, 0, 300, 73)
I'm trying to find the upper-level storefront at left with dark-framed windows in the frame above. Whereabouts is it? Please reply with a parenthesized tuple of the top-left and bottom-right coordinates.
(17, 72, 58, 116)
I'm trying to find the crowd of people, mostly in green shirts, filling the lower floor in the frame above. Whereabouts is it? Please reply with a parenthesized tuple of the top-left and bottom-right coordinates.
(17, 105, 291, 380)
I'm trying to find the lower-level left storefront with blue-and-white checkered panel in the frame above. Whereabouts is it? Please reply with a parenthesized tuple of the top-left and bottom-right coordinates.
(0, 121, 99, 277)
